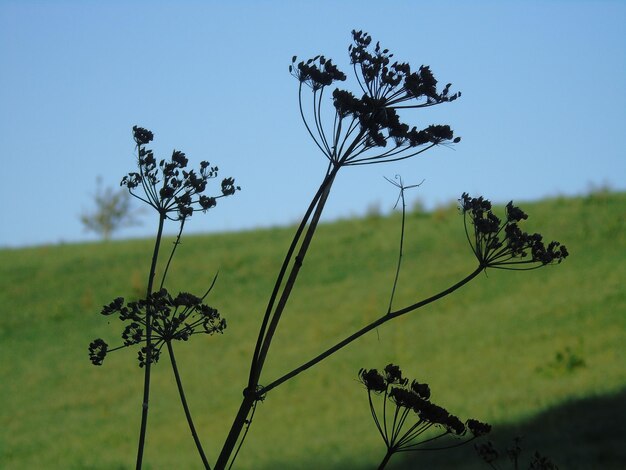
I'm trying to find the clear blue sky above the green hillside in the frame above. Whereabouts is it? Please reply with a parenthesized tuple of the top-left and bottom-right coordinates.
(0, 0, 626, 246)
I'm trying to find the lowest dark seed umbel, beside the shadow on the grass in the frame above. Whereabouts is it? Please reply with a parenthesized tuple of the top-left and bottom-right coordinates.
(359, 364, 491, 468)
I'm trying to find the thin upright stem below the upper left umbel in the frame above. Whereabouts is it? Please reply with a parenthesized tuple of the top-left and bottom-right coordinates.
(135, 214, 165, 470)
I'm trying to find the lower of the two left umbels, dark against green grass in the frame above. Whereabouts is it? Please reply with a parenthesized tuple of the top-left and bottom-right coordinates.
(89, 289, 226, 367)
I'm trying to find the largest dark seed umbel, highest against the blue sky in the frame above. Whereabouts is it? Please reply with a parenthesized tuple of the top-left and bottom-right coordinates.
(289, 31, 461, 166)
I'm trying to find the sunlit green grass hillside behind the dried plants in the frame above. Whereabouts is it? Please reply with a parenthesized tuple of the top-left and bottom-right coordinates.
(0, 192, 626, 469)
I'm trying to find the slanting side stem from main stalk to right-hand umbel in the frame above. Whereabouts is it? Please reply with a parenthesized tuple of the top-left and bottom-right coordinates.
(259, 266, 484, 394)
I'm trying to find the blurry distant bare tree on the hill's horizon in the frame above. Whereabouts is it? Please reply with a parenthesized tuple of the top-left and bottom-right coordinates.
(80, 177, 139, 240)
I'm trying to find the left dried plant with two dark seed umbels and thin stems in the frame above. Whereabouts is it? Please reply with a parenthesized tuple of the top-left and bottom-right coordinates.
(89, 126, 240, 468)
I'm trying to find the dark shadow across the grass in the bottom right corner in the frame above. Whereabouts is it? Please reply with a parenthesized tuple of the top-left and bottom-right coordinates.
(387, 390, 626, 470)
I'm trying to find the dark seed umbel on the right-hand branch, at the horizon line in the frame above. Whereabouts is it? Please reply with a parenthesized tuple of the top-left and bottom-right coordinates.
(459, 193, 569, 270)
